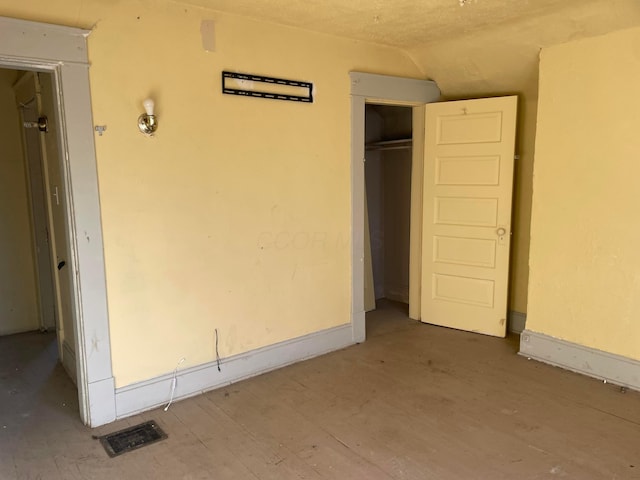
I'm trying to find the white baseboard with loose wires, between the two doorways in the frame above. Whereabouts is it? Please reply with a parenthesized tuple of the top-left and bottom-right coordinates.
(116, 323, 355, 419)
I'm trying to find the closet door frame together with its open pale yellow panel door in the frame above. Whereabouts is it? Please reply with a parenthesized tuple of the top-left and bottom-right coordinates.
(351, 72, 517, 342)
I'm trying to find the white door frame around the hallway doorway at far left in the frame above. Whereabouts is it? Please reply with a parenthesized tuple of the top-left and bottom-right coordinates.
(0, 17, 116, 427)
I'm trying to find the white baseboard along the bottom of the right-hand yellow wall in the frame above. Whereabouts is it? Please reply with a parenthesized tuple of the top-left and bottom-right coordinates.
(518, 330, 640, 390)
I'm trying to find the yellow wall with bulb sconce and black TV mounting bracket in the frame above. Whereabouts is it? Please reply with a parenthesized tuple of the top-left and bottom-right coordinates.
(0, 0, 420, 386)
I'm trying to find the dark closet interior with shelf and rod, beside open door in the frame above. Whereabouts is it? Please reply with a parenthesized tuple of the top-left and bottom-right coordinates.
(365, 104, 412, 335)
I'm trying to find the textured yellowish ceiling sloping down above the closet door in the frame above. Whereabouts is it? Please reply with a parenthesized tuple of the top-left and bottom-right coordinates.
(177, 0, 640, 96)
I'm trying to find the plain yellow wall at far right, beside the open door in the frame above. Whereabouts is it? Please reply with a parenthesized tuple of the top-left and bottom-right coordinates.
(527, 24, 640, 359)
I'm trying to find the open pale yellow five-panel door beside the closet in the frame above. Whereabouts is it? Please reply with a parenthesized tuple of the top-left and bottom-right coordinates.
(421, 96, 517, 337)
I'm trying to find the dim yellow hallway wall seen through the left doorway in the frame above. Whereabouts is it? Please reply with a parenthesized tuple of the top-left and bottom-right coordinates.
(0, 70, 40, 335)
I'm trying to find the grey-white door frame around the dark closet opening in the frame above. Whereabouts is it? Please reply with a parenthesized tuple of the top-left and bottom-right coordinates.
(349, 72, 440, 342)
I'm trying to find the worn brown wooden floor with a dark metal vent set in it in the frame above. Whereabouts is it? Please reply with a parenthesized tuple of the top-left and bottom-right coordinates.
(0, 302, 640, 480)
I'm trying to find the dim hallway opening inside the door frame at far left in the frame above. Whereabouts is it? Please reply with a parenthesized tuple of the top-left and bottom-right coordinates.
(0, 69, 77, 383)
